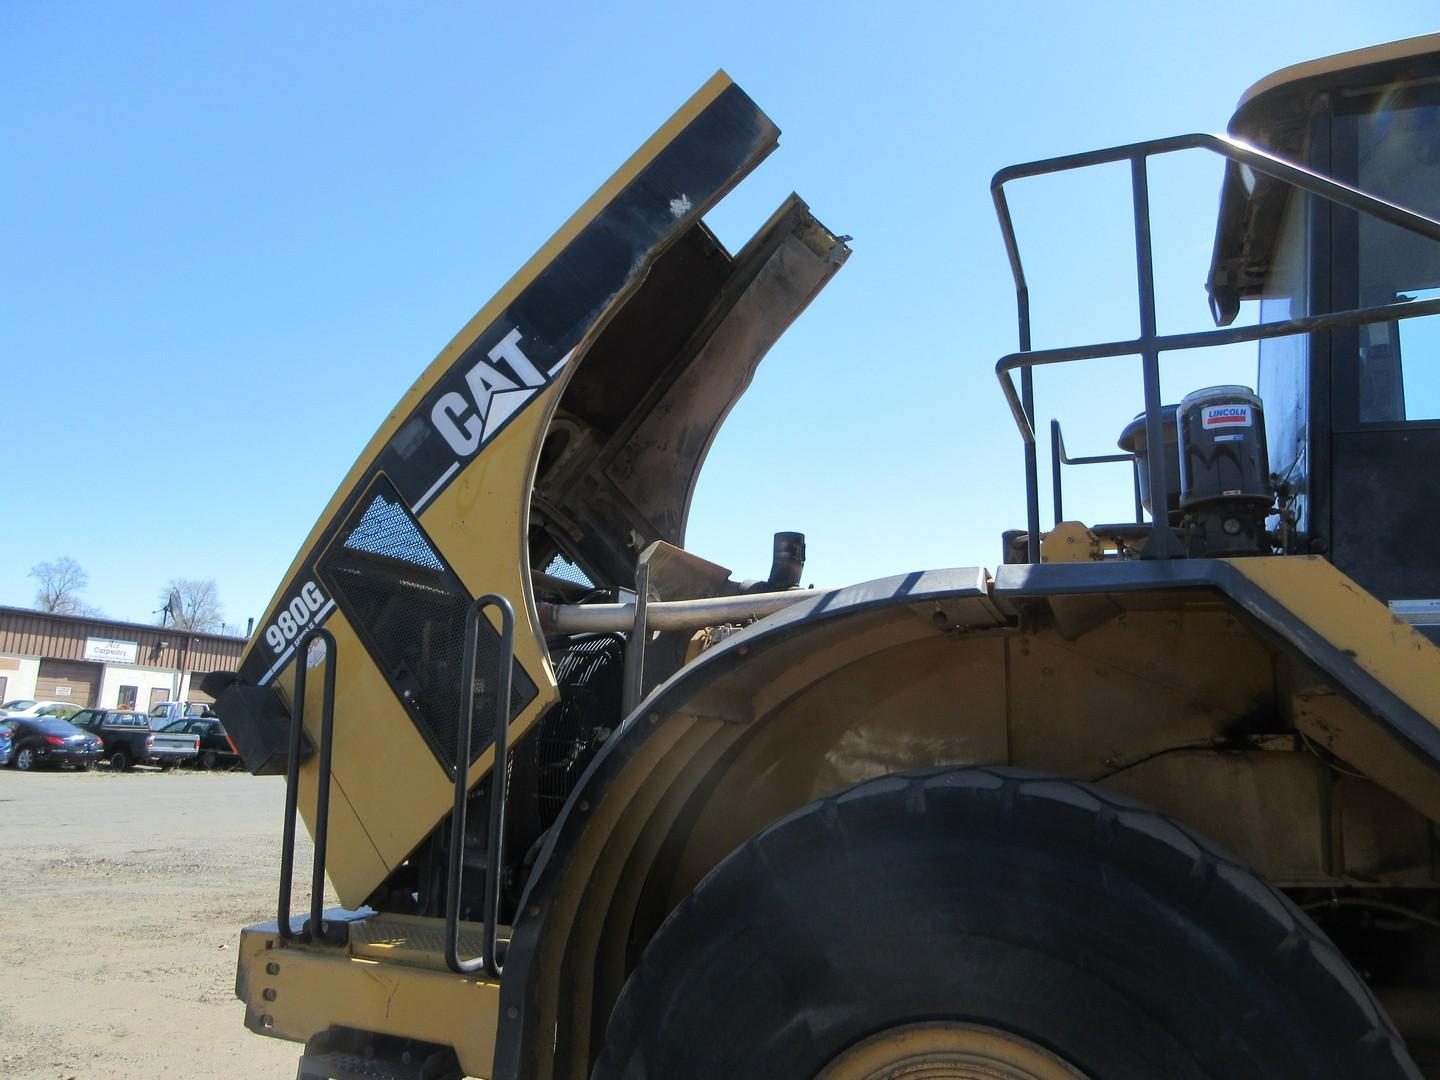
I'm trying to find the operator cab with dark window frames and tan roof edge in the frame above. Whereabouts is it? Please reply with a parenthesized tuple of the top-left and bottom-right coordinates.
(1210, 35, 1440, 625)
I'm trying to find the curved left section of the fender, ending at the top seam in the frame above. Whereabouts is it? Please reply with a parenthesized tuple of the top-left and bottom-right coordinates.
(495, 567, 1009, 1077)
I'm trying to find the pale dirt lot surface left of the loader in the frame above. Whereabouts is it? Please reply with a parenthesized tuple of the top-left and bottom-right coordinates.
(0, 769, 333, 1080)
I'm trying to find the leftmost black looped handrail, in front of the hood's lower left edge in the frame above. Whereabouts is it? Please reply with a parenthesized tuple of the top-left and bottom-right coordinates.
(275, 626, 340, 940)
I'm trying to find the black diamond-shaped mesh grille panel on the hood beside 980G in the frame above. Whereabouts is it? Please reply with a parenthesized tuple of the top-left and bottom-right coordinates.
(318, 477, 536, 770)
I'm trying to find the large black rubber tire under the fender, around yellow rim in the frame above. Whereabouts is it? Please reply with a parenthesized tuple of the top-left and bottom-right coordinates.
(593, 768, 1420, 1080)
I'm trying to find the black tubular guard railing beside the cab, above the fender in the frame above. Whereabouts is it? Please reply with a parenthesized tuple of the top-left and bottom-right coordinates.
(991, 134, 1440, 563)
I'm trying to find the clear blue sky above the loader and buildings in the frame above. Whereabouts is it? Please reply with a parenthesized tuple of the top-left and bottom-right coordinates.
(0, 0, 1436, 626)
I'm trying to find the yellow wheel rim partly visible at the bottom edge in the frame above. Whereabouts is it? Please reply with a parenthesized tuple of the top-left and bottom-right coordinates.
(816, 1021, 1086, 1080)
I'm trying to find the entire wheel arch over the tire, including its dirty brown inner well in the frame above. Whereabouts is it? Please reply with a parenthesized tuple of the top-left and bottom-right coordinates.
(495, 557, 1440, 1077)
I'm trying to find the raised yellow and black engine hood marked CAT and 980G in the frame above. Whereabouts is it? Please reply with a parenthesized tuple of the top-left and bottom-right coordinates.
(206, 72, 848, 907)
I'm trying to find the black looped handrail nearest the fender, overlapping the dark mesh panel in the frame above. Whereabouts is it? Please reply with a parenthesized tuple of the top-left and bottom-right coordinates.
(445, 593, 516, 979)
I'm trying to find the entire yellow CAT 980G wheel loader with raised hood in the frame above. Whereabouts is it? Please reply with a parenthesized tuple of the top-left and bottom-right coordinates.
(204, 35, 1440, 1080)
